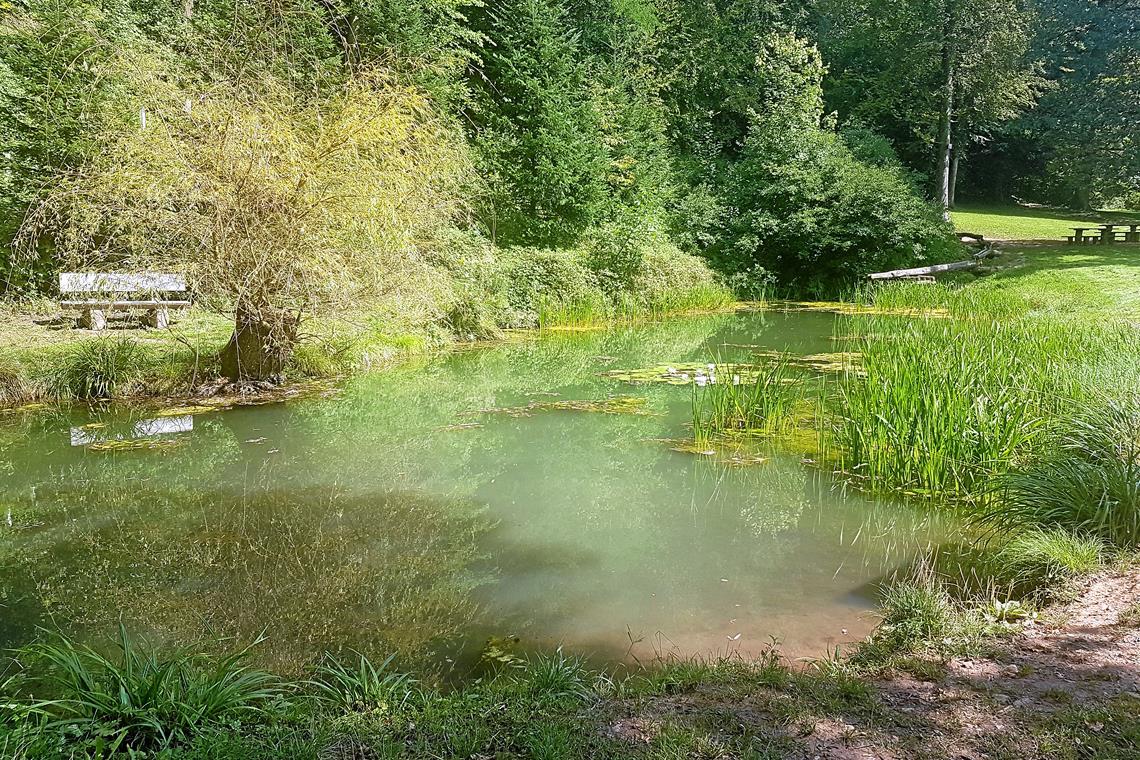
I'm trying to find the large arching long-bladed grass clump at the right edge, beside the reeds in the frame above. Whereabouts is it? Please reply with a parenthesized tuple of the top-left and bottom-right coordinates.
(983, 393, 1140, 546)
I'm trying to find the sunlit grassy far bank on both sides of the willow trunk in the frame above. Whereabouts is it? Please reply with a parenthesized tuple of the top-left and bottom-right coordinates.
(0, 247, 732, 407)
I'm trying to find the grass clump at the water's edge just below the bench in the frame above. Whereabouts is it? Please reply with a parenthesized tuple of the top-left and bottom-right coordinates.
(52, 337, 146, 399)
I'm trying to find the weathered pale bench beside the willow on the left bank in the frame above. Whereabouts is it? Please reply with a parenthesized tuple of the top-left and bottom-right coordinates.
(59, 272, 190, 329)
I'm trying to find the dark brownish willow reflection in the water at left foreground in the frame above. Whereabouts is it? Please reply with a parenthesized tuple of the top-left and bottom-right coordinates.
(5, 488, 488, 672)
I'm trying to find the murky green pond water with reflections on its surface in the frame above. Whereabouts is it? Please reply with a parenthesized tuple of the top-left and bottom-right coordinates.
(0, 312, 955, 672)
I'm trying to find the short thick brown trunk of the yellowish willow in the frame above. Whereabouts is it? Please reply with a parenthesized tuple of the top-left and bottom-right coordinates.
(219, 305, 300, 383)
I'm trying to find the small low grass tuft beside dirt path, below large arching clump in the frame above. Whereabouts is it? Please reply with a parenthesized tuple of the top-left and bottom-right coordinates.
(991, 529, 1107, 597)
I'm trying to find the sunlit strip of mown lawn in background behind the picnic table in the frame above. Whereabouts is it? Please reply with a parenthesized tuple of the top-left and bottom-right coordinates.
(952, 204, 1140, 240)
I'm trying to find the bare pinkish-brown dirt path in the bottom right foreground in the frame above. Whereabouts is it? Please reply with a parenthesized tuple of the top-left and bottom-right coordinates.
(606, 569, 1140, 760)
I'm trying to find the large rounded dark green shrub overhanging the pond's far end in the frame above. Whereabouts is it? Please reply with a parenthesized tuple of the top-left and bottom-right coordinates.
(709, 117, 959, 294)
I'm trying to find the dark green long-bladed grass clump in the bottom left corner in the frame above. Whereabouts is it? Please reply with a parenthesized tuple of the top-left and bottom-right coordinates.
(18, 626, 280, 755)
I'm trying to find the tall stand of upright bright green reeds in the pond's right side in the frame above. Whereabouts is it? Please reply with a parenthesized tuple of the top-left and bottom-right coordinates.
(832, 318, 1127, 498)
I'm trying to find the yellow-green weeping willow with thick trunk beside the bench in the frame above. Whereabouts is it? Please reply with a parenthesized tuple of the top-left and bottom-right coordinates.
(22, 64, 473, 382)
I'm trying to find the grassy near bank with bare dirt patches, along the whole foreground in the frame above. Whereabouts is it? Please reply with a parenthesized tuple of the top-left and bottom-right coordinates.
(0, 557, 1140, 760)
